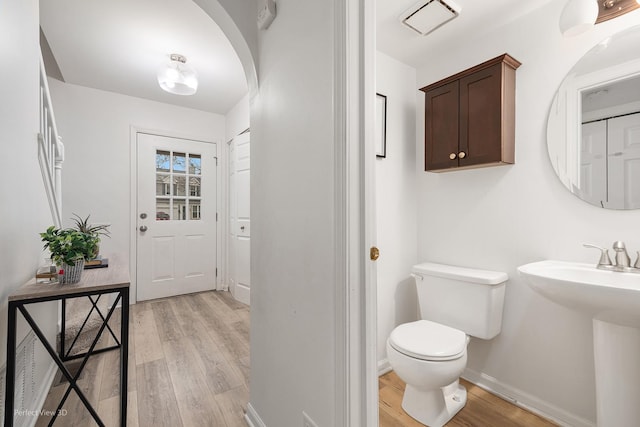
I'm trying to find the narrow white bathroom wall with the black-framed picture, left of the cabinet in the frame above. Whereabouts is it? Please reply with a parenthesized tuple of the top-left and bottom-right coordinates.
(376, 52, 419, 369)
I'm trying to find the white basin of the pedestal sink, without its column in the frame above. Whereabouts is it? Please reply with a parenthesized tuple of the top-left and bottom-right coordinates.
(518, 260, 640, 326)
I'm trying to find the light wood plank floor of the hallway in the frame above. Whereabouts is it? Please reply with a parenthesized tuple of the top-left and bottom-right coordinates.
(36, 291, 249, 427)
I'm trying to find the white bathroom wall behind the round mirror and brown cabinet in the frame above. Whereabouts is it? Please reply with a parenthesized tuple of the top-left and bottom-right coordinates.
(415, 2, 640, 425)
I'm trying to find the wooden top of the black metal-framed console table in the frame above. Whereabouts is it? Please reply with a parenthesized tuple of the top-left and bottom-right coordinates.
(9, 255, 131, 301)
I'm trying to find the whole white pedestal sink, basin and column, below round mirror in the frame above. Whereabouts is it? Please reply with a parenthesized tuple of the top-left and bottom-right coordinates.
(518, 260, 640, 427)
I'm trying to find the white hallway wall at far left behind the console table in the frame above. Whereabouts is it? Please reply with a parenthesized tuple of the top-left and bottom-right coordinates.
(0, 0, 57, 422)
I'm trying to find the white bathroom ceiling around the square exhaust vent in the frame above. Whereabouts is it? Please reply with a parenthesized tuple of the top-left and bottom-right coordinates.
(376, 0, 564, 68)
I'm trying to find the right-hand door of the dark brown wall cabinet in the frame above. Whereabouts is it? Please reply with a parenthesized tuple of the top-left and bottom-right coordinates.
(460, 63, 503, 166)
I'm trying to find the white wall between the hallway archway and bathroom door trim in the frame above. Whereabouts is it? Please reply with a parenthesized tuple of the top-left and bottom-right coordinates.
(250, 0, 336, 427)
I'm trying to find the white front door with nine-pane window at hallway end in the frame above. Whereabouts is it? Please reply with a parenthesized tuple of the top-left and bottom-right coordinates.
(136, 133, 217, 301)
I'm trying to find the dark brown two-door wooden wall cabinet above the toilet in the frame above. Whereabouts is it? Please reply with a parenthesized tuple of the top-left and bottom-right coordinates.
(420, 54, 520, 172)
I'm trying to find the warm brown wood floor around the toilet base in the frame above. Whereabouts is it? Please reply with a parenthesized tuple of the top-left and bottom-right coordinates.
(378, 371, 557, 427)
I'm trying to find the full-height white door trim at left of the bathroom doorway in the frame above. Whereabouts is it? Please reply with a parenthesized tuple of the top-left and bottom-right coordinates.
(334, 0, 379, 427)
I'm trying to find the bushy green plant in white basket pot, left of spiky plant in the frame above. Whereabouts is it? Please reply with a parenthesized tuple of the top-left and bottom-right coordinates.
(40, 225, 95, 284)
